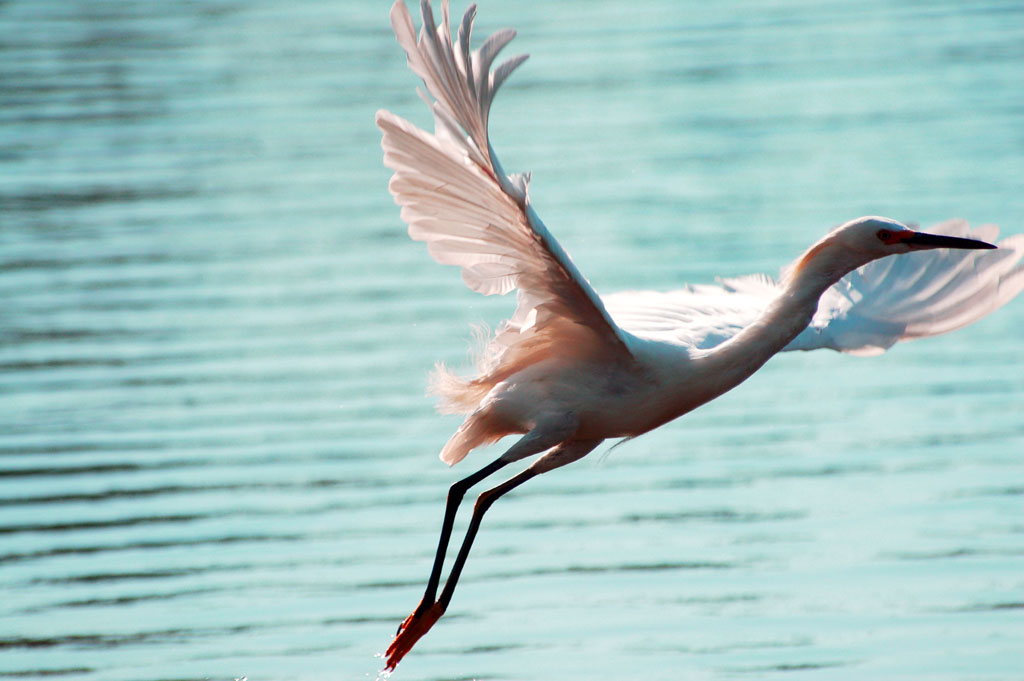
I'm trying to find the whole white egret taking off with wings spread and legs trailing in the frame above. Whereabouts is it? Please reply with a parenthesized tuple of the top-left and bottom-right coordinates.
(376, 0, 1024, 672)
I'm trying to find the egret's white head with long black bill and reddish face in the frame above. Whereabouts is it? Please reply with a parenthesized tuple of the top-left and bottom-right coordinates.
(788, 216, 995, 283)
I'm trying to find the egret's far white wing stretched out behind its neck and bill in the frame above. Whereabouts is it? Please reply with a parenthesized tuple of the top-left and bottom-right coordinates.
(605, 220, 1024, 354)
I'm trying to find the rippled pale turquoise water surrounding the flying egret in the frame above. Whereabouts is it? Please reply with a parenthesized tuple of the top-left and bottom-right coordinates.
(0, 0, 1024, 681)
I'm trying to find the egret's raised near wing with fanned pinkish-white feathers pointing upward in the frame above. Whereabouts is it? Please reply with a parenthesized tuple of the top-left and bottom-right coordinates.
(377, 0, 632, 411)
